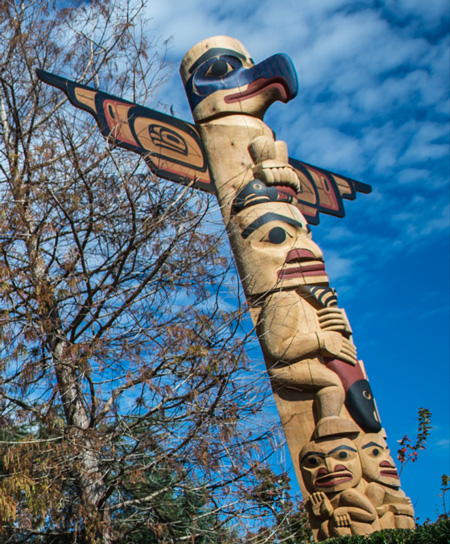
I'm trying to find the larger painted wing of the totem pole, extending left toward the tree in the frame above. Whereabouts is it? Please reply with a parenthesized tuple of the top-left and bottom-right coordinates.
(36, 70, 215, 193)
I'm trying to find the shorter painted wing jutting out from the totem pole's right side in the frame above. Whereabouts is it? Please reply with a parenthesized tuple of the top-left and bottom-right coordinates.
(289, 158, 372, 225)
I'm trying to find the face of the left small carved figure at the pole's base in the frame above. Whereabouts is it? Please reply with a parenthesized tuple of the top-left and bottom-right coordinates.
(300, 438, 361, 493)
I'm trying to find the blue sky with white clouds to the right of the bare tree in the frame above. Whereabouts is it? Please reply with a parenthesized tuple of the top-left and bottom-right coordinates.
(142, 0, 450, 521)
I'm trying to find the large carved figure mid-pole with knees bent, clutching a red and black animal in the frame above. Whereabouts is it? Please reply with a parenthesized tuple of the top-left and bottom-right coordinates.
(229, 185, 380, 437)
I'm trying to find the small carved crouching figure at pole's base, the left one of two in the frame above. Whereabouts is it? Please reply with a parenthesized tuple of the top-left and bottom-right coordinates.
(299, 438, 381, 540)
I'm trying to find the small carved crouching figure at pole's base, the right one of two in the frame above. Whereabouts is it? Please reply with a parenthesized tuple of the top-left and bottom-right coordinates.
(356, 433, 415, 529)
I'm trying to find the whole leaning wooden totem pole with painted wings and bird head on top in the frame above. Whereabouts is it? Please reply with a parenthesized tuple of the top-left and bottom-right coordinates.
(37, 36, 414, 541)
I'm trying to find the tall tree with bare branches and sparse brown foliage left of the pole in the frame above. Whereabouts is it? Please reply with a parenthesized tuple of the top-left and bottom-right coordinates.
(0, 0, 308, 543)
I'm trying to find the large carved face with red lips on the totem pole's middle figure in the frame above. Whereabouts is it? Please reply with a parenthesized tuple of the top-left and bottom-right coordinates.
(229, 202, 328, 295)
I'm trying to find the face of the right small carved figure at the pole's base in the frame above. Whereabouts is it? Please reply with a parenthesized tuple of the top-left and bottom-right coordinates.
(358, 433, 400, 488)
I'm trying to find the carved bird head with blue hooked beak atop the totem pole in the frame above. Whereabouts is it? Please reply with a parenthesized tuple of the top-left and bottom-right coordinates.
(180, 36, 298, 122)
